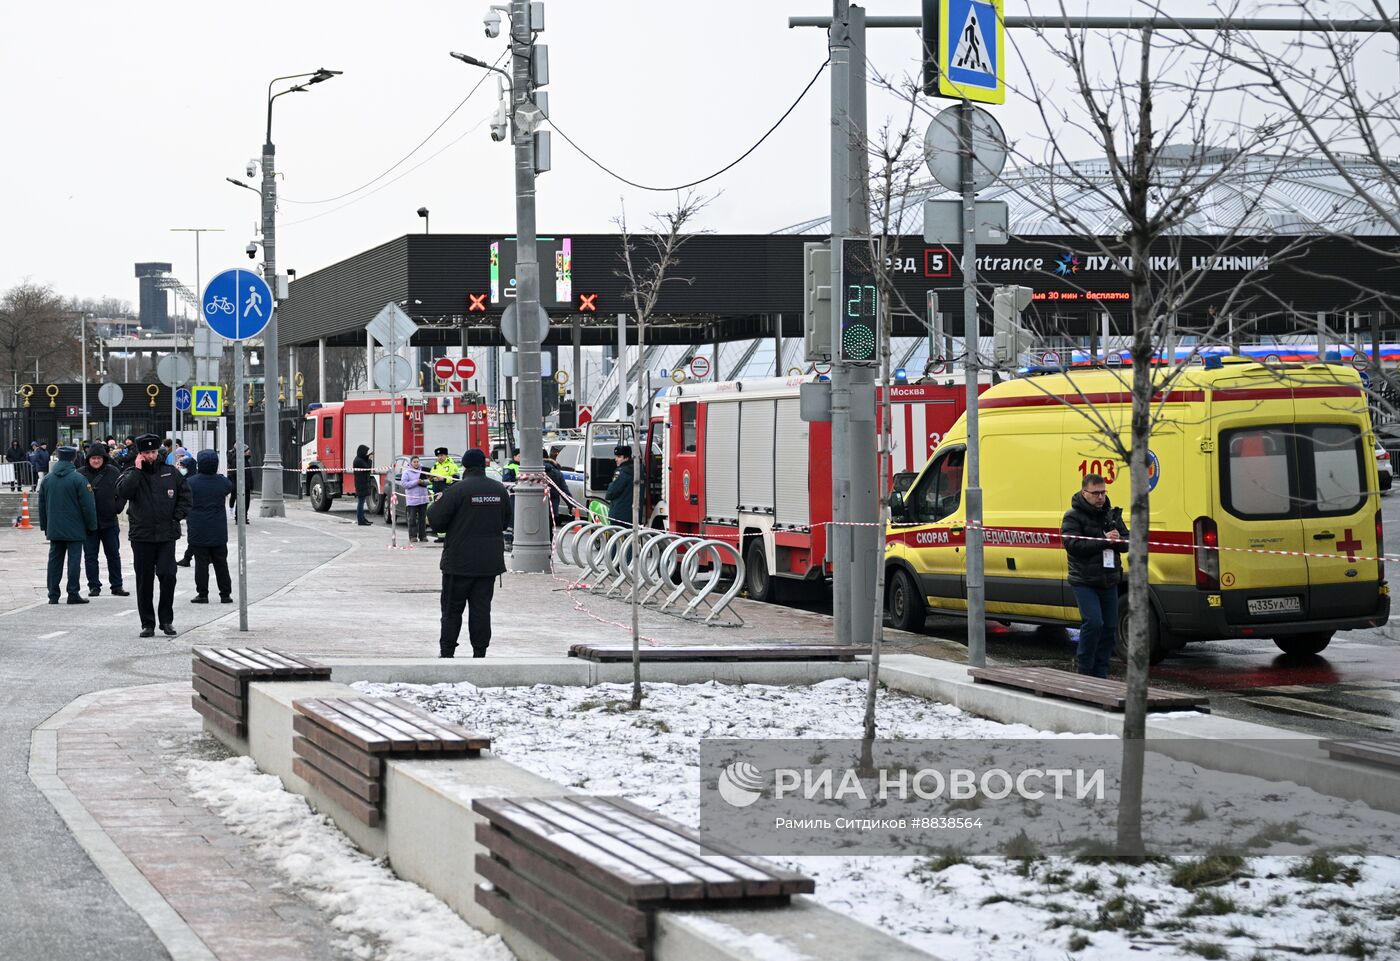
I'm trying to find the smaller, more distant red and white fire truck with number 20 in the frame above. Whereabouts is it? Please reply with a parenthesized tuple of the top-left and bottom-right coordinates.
(301, 391, 491, 514)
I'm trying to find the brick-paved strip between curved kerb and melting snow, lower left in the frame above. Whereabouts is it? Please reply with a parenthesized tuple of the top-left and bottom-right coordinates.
(31, 682, 346, 961)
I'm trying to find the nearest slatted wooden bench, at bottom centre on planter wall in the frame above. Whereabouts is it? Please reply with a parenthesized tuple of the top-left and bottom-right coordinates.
(472, 796, 816, 961)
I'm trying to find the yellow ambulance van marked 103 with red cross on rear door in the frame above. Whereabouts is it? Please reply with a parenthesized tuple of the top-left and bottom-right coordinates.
(885, 357, 1390, 663)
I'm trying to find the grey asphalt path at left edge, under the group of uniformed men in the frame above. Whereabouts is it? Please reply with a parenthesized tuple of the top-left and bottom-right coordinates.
(0, 521, 346, 961)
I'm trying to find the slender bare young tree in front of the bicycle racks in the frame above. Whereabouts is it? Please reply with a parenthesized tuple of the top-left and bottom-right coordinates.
(615, 192, 710, 710)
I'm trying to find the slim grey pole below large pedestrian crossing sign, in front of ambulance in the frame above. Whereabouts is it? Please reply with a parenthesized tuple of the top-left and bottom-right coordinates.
(958, 101, 987, 667)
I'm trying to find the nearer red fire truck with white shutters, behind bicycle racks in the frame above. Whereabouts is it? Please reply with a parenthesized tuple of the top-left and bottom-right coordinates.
(585, 375, 986, 601)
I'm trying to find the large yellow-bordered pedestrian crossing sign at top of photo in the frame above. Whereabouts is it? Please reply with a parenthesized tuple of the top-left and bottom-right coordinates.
(938, 0, 1007, 104)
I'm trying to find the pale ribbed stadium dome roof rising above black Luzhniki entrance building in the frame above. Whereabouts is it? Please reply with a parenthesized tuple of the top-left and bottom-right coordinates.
(774, 152, 1400, 237)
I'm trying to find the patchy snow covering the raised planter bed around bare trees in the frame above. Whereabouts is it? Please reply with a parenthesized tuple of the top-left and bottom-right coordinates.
(354, 679, 1400, 961)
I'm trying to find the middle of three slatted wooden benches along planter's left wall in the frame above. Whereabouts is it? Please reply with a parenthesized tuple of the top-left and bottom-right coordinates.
(291, 698, 491, 828)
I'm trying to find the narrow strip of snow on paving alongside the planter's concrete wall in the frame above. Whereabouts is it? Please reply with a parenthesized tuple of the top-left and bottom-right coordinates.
(185, 758, 515, 961)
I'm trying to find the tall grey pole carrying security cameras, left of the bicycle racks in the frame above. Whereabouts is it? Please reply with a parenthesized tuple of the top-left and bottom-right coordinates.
(452, 0, 550, 573)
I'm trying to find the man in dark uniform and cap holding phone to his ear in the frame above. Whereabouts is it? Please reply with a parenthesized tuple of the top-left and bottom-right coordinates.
(116, 434, 193, 637)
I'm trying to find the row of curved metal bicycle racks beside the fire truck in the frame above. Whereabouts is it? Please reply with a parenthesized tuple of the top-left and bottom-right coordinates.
(554, 520, 743, 628)
